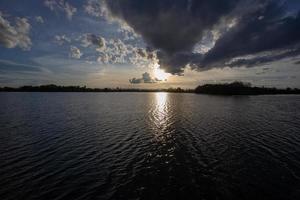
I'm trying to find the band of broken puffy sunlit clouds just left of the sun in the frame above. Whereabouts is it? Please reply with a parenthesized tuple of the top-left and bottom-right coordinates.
(54, 33, 151, 67)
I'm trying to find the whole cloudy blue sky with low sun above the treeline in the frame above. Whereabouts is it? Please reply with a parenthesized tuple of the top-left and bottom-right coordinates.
(0, 0, 300, 88)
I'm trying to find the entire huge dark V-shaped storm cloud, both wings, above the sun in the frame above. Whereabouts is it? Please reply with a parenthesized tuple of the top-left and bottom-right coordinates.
(102, 0, 300, 74)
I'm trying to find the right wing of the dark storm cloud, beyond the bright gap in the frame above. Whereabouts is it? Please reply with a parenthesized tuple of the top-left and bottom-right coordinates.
(202, 1, 300, 65)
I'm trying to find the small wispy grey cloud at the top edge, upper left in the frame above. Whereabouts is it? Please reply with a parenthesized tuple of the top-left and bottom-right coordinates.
(44, 0, 77, 19)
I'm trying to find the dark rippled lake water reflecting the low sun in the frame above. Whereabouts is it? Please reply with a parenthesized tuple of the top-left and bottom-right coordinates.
(0, 93, 300, 200)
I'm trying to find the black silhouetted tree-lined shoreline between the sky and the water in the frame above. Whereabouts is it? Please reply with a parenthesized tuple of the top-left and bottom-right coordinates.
(0, 82, 300, 95)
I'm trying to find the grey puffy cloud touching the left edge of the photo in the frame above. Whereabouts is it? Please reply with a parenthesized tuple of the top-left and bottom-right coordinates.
(0, 12, 32, 50)
